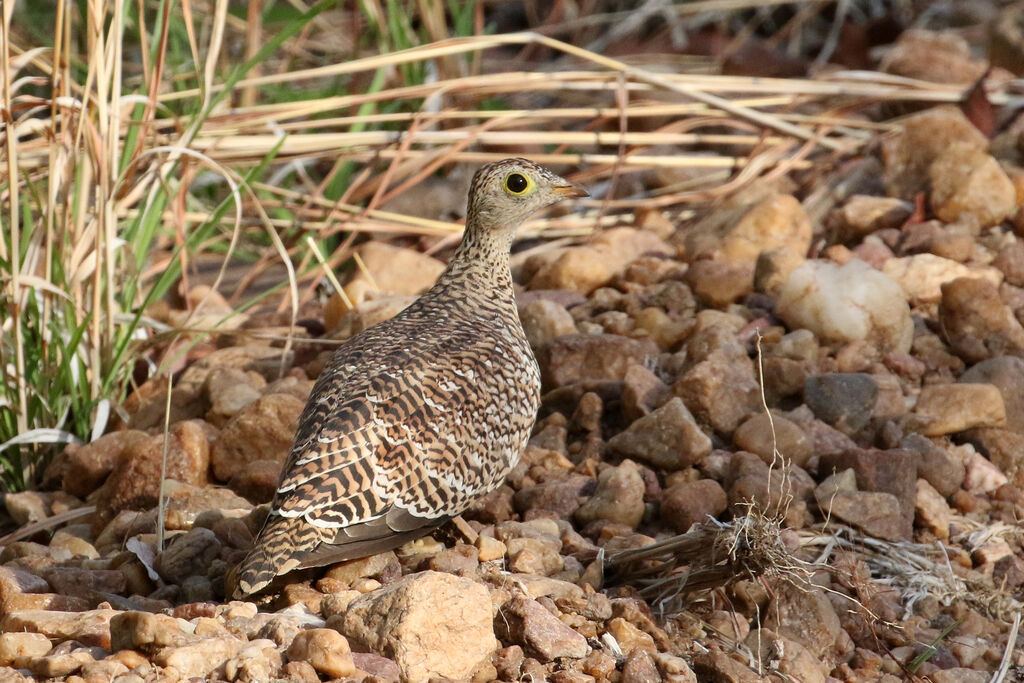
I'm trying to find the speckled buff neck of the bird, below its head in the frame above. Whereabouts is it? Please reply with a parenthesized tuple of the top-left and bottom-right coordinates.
(437, 224, 515, 305)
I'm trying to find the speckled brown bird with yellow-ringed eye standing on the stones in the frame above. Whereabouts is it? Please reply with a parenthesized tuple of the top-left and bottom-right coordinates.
(227, 159, 589, 599)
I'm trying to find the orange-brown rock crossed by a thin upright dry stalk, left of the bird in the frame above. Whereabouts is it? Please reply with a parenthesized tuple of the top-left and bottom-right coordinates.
(92, 420, 210, 532)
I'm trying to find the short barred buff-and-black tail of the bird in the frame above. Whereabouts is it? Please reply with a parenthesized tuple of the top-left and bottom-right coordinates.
(226, 513, 321, 599)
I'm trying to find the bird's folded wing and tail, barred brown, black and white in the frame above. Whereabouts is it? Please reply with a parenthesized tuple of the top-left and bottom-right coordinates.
(240, 319, 520, 590)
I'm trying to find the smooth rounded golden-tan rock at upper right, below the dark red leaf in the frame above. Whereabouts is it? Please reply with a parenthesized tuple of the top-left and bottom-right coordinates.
(928, 144, 1017, 227)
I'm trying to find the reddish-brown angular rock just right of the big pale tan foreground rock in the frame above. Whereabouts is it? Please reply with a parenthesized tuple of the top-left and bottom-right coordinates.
(495, 595, 590, 661)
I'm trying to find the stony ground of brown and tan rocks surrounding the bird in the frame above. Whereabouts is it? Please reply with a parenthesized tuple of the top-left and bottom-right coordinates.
(9, 13, 1024, 683)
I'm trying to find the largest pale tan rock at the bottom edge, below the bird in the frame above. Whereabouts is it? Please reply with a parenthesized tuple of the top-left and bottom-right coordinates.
(341, 571, 497, 683)
